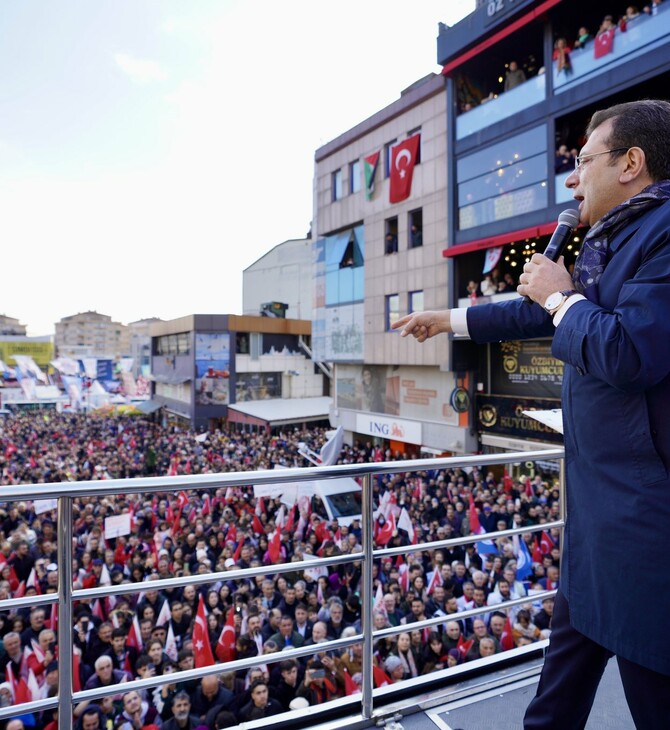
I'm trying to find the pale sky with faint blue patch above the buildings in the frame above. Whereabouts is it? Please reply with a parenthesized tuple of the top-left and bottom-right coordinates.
(0, 0, 475, 335)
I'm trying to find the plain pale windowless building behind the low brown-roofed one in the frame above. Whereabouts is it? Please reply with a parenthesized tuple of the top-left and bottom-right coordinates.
(242, 238, 314, 321)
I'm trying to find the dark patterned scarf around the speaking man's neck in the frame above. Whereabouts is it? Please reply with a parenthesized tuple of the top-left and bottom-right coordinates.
(572, 180, 670, 301)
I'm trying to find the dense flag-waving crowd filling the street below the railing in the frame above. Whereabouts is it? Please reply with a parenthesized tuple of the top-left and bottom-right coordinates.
(0, 411, 560, 730)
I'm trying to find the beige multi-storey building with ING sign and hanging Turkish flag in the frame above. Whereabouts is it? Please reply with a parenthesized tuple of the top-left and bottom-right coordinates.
(313, 74, 476, 454)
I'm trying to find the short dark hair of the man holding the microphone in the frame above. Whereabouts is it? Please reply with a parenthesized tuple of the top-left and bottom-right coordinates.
(586, 99, 670, 181)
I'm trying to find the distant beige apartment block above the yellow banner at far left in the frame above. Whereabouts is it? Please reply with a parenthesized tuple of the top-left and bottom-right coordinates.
(55, 312, 130, 360)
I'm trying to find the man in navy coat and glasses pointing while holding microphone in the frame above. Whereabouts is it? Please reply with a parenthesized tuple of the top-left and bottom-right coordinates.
(393, 100, 670, 730)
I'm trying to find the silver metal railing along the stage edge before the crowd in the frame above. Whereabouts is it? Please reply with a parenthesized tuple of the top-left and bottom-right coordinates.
(0, 448, 565, 730)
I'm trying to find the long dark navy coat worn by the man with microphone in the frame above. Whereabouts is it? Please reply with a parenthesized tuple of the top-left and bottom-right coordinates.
(467, 202, 670, 674)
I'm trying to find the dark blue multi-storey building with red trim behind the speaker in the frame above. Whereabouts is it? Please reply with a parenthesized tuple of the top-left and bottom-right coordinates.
(438, 0, 670, 450)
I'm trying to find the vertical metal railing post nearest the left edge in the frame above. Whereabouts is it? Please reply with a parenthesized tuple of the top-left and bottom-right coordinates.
(57, 495, 73, 730)
